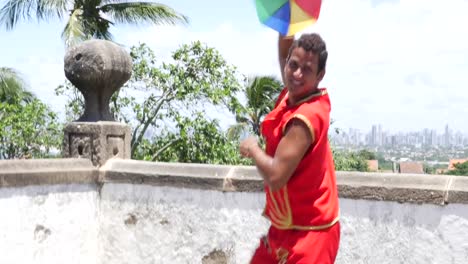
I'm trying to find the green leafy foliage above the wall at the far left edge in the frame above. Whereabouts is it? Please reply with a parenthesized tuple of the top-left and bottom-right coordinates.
(0, 97, 62, 159)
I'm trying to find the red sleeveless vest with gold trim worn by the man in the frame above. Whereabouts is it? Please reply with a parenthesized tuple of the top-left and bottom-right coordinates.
(261, 89, 339, 230)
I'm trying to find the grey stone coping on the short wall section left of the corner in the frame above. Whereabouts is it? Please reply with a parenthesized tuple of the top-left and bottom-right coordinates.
(0, 159, 99, 187)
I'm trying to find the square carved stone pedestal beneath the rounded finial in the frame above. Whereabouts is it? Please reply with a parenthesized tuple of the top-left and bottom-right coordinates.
(62, 121, 131, 166)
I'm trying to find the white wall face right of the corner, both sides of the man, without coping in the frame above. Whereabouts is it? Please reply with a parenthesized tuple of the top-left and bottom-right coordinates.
(100, 184, 468, 264)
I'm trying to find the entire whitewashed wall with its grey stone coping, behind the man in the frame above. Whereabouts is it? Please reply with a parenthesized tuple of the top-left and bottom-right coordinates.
(0, 159, 468, 264)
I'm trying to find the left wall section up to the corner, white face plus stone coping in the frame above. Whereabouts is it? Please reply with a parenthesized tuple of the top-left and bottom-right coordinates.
(0, 159, 98, 264)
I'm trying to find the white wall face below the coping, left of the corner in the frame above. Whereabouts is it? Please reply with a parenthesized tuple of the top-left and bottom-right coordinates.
(0, 185, 99, 264)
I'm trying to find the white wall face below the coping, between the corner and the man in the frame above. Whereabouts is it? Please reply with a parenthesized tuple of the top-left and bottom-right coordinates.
(100, 184, 268, 264)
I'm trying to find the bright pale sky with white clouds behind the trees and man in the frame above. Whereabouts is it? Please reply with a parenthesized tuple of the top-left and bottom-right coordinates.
(0, 0, 468, 134)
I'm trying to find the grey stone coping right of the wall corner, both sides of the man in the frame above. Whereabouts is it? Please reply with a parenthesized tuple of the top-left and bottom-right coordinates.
(101, 160, 468, 205)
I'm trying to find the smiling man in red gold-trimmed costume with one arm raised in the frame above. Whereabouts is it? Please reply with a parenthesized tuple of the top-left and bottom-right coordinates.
(240, 34, 340, 264)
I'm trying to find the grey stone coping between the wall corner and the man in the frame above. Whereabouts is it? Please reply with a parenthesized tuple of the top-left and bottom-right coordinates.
(100, 159, 263, 191)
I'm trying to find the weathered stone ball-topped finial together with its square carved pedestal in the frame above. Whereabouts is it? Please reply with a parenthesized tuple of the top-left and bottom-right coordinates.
(63, 40, 132, 166)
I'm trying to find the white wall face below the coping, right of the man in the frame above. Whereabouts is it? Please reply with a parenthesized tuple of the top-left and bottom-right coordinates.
(337, 199, 468, 264)
